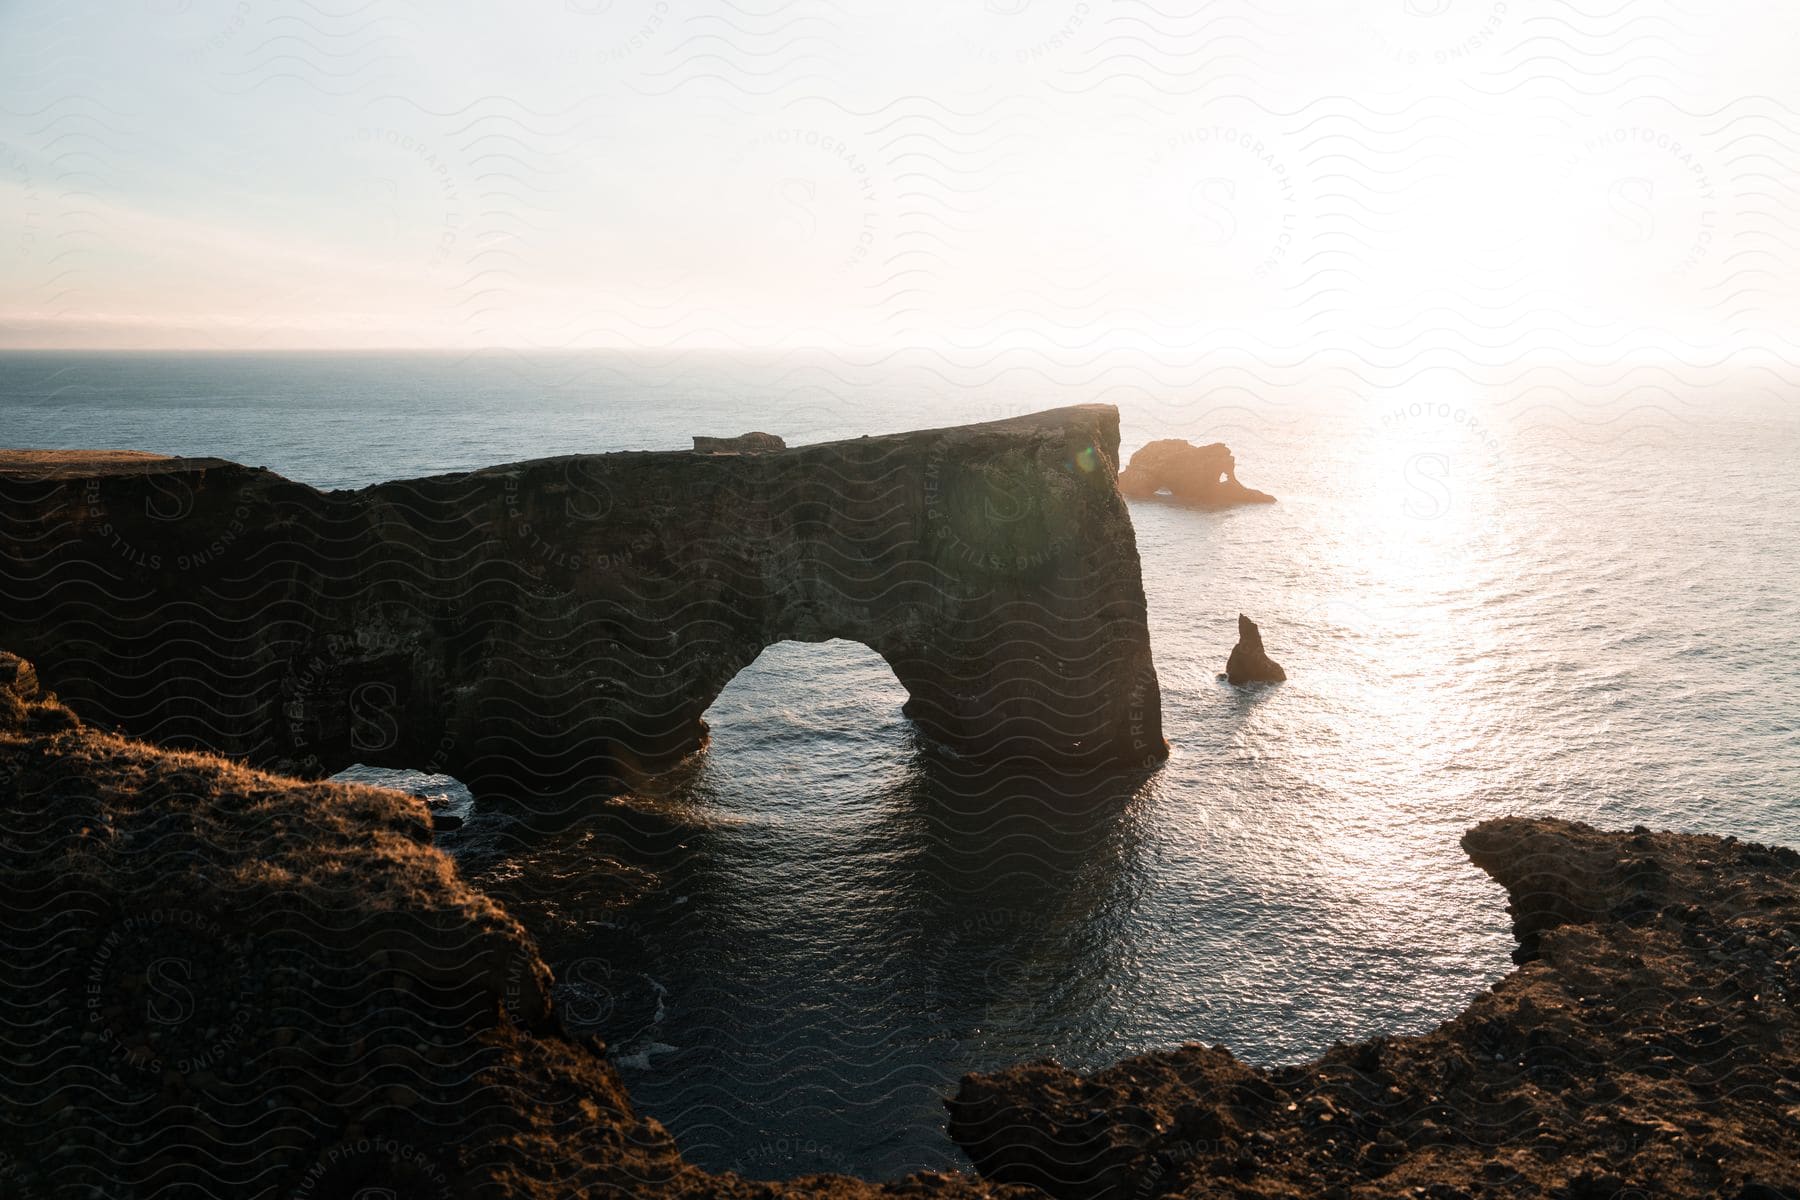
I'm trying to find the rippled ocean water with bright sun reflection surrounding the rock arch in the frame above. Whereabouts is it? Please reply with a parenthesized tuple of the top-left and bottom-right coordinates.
(0, 353, 1800, 1178)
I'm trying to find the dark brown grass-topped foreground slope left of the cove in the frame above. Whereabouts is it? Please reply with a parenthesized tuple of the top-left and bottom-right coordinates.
(0, 653, 1037, 1200)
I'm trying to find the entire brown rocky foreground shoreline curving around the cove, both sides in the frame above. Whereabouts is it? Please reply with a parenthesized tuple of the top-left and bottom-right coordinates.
(0, 655, 1800, 1200)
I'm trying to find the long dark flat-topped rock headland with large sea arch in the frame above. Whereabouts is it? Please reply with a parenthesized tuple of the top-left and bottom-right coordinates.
(0, 405, 1166, 795)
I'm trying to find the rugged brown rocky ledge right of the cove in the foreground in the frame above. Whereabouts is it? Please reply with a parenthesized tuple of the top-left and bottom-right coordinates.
(950, 819, 1800, 1200)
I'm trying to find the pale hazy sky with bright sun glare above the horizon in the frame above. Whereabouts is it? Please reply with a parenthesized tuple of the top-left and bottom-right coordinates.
(0, 0, 1800, 359)
